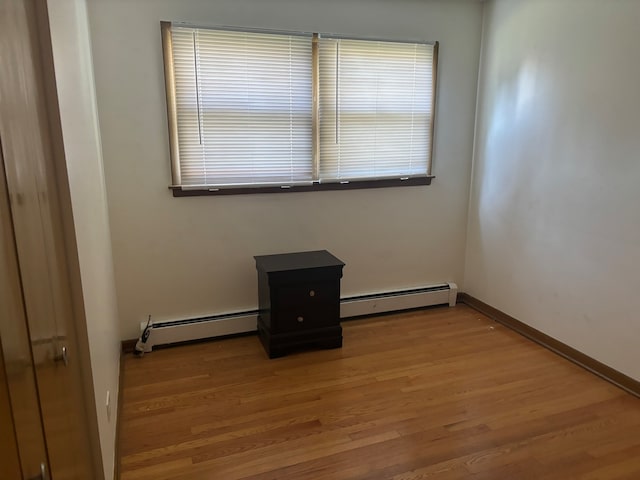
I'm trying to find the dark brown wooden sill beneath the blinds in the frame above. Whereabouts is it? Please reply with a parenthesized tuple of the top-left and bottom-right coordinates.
(169, 176, 435, 197)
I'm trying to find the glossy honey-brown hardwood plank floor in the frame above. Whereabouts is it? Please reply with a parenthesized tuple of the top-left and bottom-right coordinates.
(120, 306, 640, 480)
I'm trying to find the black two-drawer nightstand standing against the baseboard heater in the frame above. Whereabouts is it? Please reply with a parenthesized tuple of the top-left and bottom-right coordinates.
(254, 250, 344, 358)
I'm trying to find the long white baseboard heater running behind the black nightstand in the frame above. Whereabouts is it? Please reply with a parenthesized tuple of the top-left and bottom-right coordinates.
(140, 283, 458, 352)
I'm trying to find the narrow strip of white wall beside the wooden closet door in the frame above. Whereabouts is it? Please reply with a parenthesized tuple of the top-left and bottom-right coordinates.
(48, 0, 120, 480)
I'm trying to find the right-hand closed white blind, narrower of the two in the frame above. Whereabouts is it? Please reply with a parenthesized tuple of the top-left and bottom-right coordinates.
(319, 38, 434, 182)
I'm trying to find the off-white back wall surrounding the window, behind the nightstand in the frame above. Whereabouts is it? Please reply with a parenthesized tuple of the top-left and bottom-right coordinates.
(89, 0, 482, 338)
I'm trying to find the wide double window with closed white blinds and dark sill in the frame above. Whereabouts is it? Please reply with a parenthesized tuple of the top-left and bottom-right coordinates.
(162, 22, 437, 196)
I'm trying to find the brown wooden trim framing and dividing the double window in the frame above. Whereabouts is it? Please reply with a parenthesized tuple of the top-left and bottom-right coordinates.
(160, 21, 439, 197)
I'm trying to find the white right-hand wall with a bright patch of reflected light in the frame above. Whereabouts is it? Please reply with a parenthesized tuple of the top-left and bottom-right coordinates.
(464, 0, 640, 380)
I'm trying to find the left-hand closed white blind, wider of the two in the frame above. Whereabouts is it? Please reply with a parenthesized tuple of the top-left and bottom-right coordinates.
(171, 25, 313, 187)
